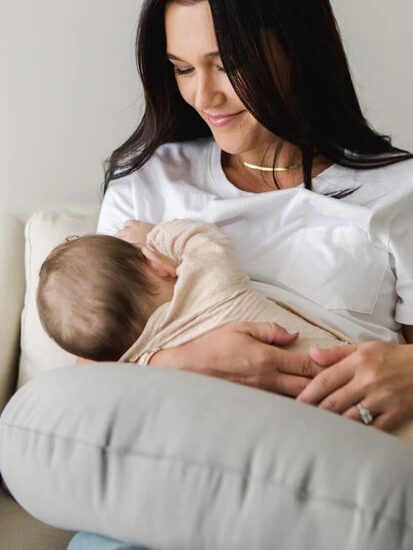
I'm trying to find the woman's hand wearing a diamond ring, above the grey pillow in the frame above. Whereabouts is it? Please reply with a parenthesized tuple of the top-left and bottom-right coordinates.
(298, 342, 413, 431)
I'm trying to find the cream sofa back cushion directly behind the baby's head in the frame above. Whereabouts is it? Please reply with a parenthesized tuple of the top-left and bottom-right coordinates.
(18, 205, 99, 386)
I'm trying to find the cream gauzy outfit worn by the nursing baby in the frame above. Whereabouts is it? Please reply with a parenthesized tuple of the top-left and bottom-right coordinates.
(120, 220, 348, 364)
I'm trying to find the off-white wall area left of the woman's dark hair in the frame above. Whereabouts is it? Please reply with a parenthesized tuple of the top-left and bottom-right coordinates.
(0, 0, 141, 218)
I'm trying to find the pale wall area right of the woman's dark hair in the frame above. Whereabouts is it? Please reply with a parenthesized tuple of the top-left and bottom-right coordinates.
(331, 0, 413, 152)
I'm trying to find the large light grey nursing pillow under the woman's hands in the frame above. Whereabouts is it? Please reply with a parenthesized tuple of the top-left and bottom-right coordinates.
(0, 363, 413, 550)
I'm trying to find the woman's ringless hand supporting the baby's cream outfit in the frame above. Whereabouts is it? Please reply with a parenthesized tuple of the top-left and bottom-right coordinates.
(149, 322, 323, 397)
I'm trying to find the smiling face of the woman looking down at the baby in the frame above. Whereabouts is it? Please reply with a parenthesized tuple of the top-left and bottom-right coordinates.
(165, 1, 274, 154)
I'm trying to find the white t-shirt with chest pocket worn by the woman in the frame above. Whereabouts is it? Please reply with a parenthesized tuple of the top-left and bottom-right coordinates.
(98, 138, 413, 342)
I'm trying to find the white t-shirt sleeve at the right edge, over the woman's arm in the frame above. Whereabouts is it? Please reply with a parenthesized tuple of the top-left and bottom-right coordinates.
(389, 197, 413, 325)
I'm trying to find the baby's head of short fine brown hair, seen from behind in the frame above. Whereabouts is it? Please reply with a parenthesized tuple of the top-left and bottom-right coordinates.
(37, 235, 156, 361)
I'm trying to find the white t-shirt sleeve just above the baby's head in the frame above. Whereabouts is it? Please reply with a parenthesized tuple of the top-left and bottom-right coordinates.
(97, 177, 136, 235)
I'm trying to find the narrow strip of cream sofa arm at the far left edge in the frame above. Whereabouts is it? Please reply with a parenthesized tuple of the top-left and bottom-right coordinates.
(0, 214, 24, 413)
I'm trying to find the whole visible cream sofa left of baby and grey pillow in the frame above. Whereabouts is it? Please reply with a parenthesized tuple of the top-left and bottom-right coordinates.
(0, 207, 97, 550)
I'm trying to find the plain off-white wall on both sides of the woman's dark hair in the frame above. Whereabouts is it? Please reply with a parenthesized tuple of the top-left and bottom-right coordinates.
(0, 0, 413, 218)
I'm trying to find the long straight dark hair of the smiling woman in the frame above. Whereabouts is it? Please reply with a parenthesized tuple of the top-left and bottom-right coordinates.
(104, 0, 413, 191)
